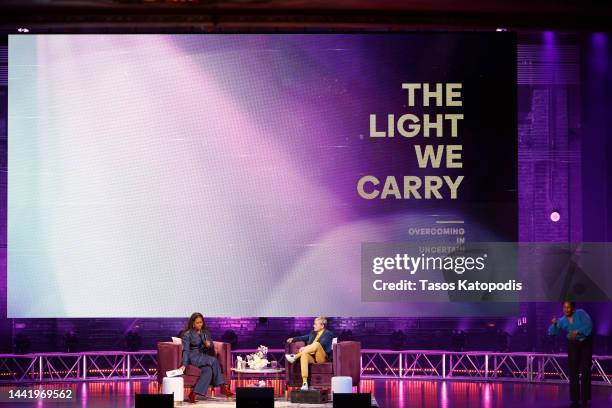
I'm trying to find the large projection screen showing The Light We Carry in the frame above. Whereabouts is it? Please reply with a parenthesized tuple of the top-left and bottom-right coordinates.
(8, 33, 517, 318)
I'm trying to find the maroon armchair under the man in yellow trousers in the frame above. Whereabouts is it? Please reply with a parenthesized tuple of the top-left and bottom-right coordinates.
(285, 341, 361, 396)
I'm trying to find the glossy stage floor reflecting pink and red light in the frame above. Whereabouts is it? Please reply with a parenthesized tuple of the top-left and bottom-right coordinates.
(0, 379, 612, 408)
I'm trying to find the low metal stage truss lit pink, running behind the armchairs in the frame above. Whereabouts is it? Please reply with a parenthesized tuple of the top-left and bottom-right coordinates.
(0, 349, 612, 386)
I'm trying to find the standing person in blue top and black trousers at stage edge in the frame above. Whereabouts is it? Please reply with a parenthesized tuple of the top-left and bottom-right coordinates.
(548, 302, 593, 407)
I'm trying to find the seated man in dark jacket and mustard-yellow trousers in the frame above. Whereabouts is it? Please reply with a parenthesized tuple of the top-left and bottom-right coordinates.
(285, 316, 334, 390)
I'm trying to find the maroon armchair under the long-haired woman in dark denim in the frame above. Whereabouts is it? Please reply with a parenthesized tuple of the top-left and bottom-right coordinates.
(157, 341, 232, 388)
